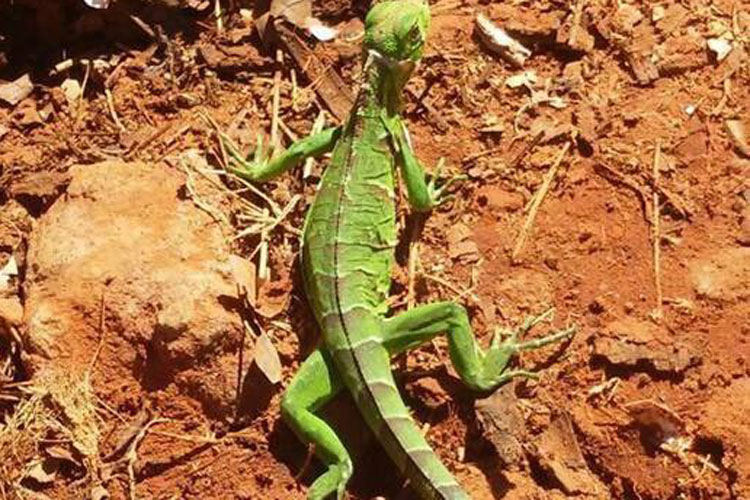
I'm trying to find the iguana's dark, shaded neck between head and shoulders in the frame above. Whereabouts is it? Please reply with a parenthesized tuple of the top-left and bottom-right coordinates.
(358, 50, 414, 117)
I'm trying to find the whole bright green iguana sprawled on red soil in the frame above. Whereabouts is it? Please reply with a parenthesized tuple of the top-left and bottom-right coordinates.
(227, 0, 572, 499)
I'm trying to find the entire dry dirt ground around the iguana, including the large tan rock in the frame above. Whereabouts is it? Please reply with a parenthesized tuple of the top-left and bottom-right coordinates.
(0, 0, 750, 499)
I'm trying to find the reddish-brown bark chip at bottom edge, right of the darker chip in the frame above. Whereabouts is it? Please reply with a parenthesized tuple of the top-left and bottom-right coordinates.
(536, 412, 604, 497)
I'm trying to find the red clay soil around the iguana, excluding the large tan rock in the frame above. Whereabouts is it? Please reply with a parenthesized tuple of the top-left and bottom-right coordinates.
(0, 0, 750, 499)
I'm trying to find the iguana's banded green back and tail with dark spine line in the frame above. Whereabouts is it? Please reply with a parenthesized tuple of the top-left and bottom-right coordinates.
(302, 67, 468, 499)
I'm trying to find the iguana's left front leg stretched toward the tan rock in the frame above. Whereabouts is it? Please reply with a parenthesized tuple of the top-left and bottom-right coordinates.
(221, 127, 341, 182)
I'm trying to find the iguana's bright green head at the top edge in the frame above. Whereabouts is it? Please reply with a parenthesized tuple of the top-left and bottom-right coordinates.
(364, 0, 430, 64)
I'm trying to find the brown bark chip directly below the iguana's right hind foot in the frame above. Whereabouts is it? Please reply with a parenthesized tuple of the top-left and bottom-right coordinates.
(474, 383, 528, 469)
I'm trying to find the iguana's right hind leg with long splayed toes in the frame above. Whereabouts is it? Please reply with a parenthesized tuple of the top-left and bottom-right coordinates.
(383, 302, 575, 391)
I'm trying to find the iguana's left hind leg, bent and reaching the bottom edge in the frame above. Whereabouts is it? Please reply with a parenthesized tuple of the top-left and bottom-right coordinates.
(281, 348, 352, 500)
